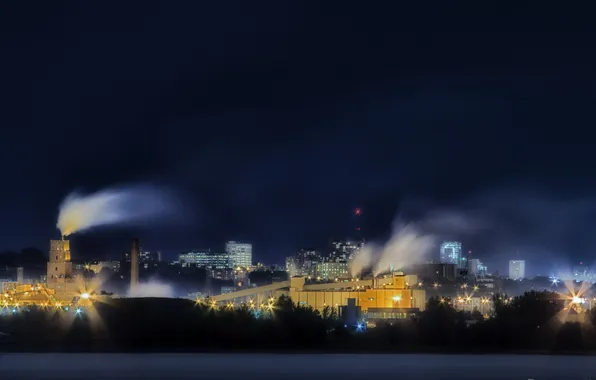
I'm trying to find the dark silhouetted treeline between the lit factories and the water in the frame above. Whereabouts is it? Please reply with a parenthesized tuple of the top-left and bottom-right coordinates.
(0, 292, 596, 352)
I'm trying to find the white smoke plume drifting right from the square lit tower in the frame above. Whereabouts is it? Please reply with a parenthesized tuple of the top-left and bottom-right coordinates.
(57, 186, 181, 236)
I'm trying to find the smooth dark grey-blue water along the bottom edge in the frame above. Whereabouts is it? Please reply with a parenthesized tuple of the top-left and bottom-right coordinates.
(0, 354, 596, 380)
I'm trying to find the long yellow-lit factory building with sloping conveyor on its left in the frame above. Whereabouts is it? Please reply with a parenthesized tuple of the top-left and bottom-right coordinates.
(209, 273, 426, 319)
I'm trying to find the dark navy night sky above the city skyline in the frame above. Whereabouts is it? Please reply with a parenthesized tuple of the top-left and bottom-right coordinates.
(0, 0, 596, 274)
